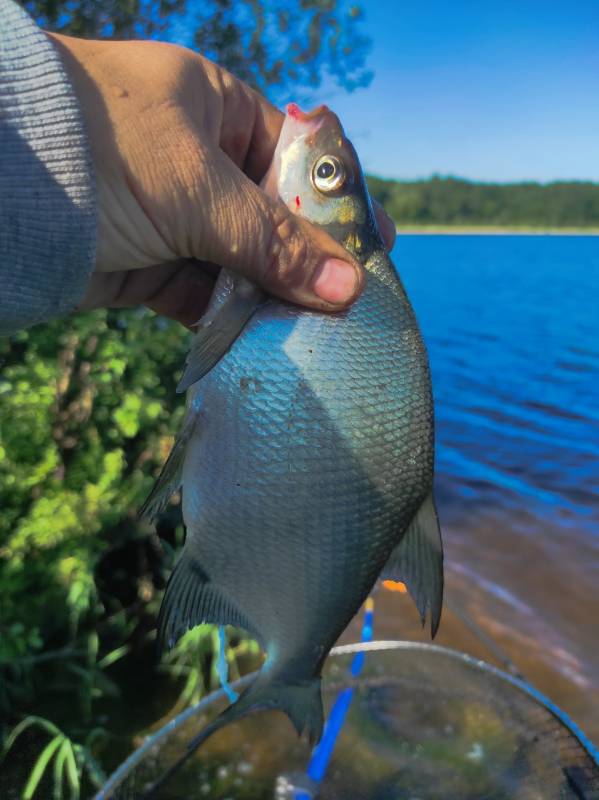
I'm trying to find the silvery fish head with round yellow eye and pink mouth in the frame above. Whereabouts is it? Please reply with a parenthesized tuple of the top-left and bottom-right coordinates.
(262, 103, 384, 261)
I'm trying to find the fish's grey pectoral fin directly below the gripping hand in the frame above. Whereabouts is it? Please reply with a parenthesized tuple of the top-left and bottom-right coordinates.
(177, 269, 265, 392)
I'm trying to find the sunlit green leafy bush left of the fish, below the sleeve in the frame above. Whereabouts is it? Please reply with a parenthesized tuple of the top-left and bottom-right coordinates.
(0, 311, 188, 791)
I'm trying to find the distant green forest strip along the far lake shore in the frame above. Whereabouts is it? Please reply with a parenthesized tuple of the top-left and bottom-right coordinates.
(368, 176, 599, 228)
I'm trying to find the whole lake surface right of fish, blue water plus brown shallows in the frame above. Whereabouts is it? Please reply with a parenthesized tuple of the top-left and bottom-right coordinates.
(368, 236, 599, 739)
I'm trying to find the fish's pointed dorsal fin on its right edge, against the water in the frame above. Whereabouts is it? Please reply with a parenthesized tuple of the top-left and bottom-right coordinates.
(381, 492, 443, 636)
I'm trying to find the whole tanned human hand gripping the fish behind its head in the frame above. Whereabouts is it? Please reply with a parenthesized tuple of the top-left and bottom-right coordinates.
(52, 35, 395, 326)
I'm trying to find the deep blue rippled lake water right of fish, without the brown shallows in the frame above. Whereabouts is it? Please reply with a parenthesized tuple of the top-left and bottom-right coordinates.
(394, 236, 599, 524)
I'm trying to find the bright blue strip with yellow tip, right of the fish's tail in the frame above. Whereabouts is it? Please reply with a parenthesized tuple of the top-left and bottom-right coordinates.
(293, 597, 374, 800)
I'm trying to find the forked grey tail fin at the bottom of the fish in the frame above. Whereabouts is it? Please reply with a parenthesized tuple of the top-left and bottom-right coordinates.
(188, 676, 324, 752)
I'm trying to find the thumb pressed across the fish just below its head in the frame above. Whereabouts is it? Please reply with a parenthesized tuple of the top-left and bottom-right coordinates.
(195, 153, 364, 311)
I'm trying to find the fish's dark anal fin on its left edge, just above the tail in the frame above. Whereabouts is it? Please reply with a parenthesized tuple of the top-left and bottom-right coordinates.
(158, 546, 259, 652)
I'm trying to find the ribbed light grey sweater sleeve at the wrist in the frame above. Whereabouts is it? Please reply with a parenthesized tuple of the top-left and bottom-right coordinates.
(0, 0, 96, 334)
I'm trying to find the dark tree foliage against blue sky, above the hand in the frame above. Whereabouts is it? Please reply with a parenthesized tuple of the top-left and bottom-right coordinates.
(22, 0, 372, 100)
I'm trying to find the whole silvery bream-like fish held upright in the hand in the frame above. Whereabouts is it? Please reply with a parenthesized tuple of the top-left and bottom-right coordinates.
(143, 104, 443, 748)
